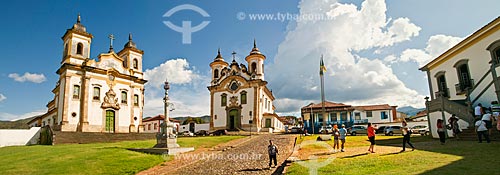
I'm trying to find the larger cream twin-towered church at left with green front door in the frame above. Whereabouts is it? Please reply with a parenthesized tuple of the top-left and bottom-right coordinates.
(28, 16, 147, 133)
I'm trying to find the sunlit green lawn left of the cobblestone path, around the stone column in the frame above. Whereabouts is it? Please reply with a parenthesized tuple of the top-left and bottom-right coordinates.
(0, 136, 244, 175)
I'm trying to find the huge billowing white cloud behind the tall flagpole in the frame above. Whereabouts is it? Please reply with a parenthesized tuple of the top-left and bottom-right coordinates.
(266, 0, 424, 113)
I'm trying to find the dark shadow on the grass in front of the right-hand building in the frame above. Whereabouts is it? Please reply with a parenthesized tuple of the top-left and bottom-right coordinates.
(377, 136, 500, 174)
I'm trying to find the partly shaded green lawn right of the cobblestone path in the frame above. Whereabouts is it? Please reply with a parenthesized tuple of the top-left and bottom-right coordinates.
(287, 136, 500, 175)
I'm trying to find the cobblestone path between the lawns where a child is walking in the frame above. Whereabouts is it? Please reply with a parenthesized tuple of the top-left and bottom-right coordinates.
(155, 134, 295, 175)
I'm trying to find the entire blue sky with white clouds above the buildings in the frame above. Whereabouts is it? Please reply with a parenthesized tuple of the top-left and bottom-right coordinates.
(0, 0, 499, 120)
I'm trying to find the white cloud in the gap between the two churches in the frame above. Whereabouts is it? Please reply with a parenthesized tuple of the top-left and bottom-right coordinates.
(144, 58, 210, 117)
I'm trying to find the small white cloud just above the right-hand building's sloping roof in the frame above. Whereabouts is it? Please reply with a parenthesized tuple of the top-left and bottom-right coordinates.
(398, 35, 463, 67)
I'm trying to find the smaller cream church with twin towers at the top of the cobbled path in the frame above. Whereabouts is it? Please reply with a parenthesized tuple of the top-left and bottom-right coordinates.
(208, 41, 284, 132)
